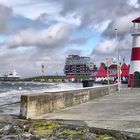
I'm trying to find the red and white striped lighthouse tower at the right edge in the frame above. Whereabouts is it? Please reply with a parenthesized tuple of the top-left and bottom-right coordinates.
(128, 17, 140, 87)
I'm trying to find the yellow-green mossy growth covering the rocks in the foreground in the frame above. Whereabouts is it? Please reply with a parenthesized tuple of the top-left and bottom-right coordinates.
(21, 121, 121, 140)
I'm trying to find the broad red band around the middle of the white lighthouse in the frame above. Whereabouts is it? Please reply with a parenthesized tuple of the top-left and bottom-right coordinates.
(131, 47, 140, 60)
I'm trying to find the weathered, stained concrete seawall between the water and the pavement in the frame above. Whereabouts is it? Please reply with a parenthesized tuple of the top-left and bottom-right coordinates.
(20, 85, 118, 119)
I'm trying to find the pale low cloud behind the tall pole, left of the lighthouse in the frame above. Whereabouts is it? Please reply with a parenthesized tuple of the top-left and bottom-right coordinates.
(91, 35, 132, 65)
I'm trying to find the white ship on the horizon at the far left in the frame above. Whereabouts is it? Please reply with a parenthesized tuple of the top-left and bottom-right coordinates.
(0, 69, 21, 81)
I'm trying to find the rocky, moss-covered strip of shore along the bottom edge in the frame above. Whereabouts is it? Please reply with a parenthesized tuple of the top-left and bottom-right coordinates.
(0, 115, 140, 140)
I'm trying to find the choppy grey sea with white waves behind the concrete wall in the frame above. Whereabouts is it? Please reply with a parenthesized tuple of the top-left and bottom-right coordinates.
(0, 81, 101, 116)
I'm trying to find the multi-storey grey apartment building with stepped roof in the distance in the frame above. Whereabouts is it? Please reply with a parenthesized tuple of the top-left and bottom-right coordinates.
(64, 55, 95, 76)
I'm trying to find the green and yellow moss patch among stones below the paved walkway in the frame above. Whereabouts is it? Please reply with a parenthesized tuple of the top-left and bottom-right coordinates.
(18, 120, 127, 140)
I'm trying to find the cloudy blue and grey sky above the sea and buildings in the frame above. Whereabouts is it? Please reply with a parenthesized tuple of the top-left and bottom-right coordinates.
(0, 0, 140, 77)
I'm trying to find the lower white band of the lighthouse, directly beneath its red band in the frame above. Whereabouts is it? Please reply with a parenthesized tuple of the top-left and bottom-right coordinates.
(129, 60, 140, 74)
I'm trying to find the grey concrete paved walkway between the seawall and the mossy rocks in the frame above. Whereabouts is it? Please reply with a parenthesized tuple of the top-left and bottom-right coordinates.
(38, 88, 140, 133)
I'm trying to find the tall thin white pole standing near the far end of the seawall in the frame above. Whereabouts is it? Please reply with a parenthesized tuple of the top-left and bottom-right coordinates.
(115, 29, 120, 91)
